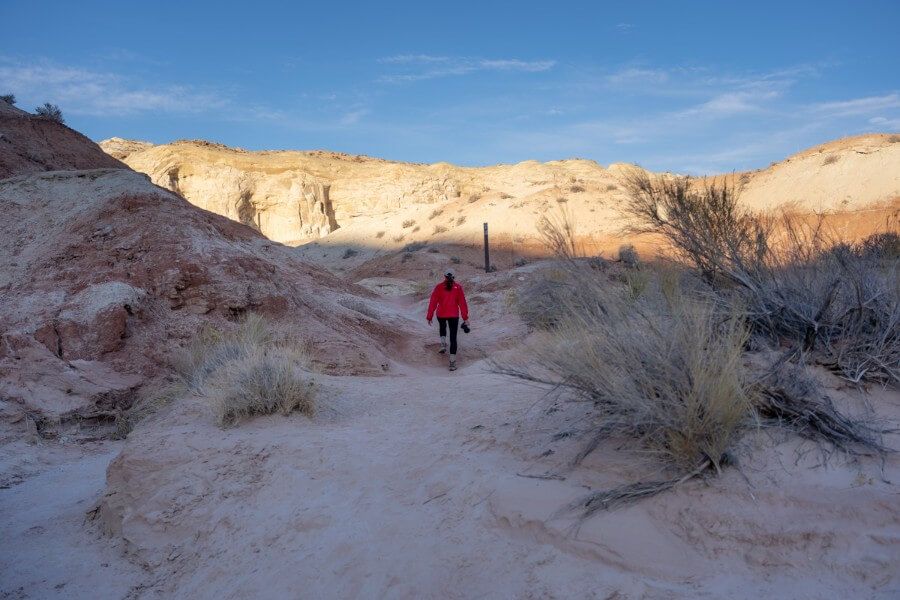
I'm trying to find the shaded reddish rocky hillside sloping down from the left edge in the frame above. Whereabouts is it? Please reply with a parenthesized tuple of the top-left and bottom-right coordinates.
(0, 117, 404, 432)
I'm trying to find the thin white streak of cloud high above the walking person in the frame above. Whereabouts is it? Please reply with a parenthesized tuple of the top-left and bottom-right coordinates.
(378, 54, 556, 83)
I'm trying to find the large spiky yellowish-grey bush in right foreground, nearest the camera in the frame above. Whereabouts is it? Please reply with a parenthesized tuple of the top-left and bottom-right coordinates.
(495, 272, 753, 470)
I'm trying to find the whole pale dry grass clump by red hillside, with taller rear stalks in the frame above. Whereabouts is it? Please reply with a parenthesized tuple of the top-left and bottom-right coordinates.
(174, 314, 315, 426)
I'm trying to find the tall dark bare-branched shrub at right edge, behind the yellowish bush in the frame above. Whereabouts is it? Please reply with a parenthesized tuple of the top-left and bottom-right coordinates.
(626, 170, 900, 383)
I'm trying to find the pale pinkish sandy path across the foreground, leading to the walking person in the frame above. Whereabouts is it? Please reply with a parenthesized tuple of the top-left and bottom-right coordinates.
(0, 284, 900, 599)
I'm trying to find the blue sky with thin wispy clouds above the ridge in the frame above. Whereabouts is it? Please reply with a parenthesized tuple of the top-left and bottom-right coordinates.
(0, 0, 900, 173)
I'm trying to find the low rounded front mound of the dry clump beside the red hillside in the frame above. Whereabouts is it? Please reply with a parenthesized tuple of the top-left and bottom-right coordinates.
(208, 347, 315, 426)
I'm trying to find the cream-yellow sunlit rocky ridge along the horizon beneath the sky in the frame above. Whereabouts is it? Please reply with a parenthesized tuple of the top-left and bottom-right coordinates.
(101, 135, 900, 251)
